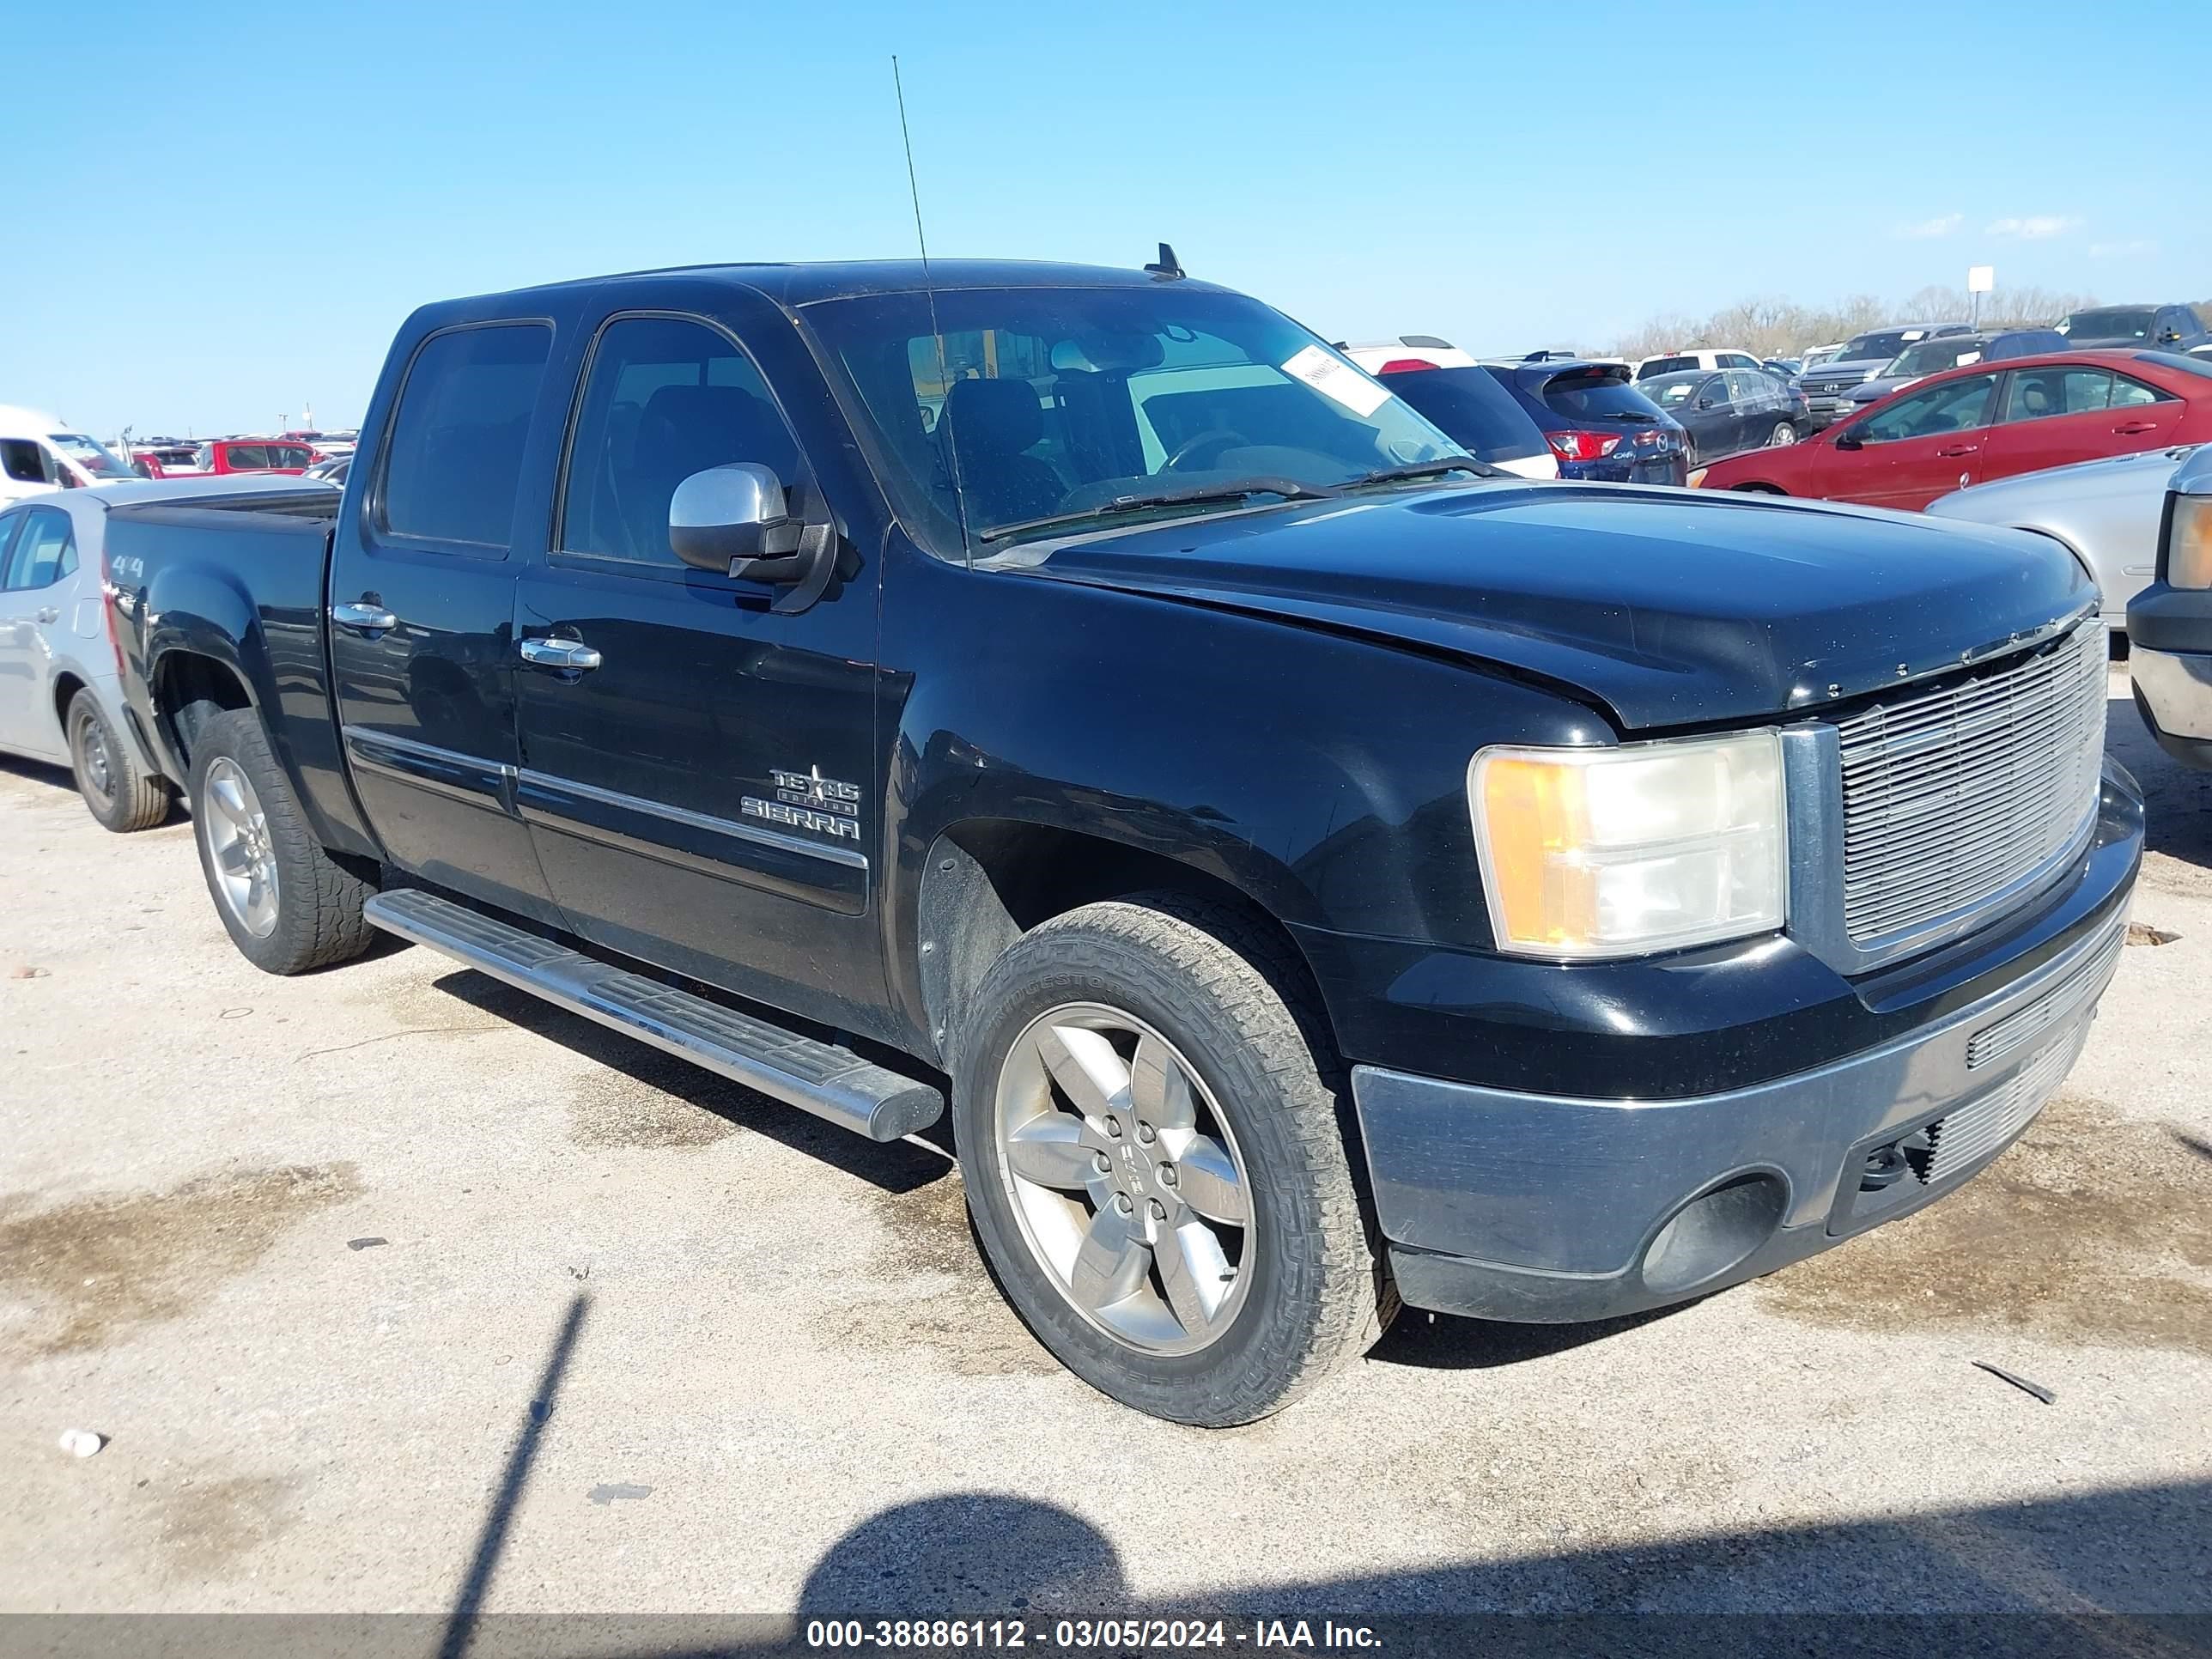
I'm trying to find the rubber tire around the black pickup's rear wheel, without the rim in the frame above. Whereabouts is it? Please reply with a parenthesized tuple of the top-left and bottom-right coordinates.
(191, 708, 376, 973)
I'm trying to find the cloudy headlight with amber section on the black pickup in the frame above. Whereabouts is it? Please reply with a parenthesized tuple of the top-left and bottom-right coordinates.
(1467, 732, 1790, 957)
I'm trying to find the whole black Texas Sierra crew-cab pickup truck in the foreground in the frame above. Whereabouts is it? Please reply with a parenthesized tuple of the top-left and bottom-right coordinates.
(108, 261, 2142, 1425)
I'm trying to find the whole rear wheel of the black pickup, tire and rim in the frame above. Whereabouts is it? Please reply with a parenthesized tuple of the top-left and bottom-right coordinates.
(192, 708, 376, 973)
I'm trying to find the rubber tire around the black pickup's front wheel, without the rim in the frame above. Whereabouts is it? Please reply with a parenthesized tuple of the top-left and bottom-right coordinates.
(953, 894, 1395, 1427)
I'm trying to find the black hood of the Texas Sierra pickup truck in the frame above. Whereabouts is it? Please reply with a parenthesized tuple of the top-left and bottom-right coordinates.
(1012, 483, 2094, 730)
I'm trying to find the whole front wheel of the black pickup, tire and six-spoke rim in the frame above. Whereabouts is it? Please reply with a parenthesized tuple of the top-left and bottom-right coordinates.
(956, 896, 1387, 1427)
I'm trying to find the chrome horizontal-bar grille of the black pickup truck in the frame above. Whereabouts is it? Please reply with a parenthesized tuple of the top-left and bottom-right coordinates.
(1838, 617, 2106, 947)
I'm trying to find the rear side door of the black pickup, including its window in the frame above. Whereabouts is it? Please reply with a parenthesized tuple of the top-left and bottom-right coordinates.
(327, 321, 560, 921)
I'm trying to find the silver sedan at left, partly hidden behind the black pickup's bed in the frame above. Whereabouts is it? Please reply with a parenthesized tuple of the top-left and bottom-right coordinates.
(0, 476, 331, 832)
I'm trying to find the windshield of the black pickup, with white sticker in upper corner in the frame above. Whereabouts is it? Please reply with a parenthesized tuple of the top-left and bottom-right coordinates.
(803, 283, 1464, 557)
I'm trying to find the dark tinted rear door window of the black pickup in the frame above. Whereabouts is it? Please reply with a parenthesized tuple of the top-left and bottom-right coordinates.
(376, 323, 553, 550)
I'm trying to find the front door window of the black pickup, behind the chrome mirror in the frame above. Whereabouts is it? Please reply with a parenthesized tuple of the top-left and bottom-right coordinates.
(556, 316, 801, 564)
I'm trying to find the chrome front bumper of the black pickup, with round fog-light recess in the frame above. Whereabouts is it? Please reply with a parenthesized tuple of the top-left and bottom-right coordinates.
(1352, 810, 2142, 1322)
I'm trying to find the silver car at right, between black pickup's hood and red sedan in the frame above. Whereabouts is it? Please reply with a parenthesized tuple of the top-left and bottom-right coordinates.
(1927, 445, 2190, 630)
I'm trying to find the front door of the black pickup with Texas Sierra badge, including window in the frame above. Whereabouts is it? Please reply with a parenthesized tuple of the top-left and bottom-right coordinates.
(515, 312, 884, 1029)
